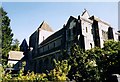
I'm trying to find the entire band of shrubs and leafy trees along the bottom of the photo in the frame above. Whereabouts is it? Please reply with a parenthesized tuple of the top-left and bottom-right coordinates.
(3, 40, 120, 82)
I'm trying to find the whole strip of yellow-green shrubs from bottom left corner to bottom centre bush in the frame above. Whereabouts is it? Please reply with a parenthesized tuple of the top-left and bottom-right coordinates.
(2, 60, 70, 82)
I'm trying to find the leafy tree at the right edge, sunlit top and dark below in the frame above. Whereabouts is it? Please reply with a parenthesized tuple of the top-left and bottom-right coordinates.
(101, 40, 120, 80)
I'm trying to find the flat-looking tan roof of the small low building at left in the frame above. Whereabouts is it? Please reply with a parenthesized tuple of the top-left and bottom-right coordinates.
(8, 51, 24, 60)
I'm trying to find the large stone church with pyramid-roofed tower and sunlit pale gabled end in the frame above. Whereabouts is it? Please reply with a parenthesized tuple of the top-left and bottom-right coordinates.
(22, 10, 120, 73)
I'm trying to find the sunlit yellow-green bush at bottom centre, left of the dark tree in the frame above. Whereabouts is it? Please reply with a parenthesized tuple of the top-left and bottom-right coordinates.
(48, 60, 71, 81)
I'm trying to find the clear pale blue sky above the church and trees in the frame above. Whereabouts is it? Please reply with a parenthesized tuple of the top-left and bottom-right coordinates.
(2, 2, 118, 43)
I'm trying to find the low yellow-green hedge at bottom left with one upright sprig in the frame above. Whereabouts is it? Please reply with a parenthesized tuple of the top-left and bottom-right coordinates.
(2, 62, 48, 82)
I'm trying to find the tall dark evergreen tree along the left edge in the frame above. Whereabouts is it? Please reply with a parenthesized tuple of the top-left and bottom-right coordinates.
(0, 7, 13, 64)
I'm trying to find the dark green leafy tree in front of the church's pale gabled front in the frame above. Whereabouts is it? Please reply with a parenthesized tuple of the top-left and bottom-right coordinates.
(68, 45, 102, 82)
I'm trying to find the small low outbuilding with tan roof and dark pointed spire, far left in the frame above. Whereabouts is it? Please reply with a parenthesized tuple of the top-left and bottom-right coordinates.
(6, 39, 28, 73)
